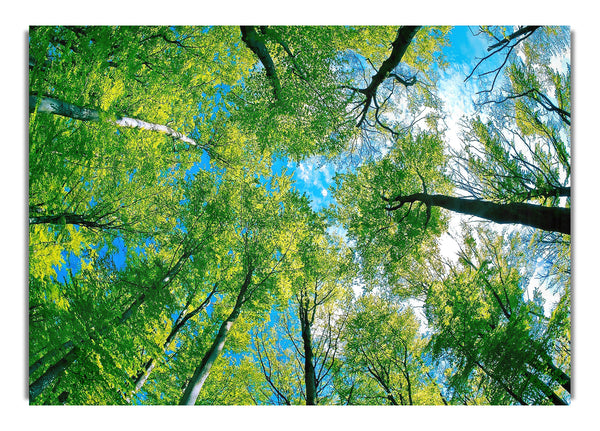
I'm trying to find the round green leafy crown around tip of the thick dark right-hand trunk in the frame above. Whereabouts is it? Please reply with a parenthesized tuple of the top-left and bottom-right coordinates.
(332, 134, 448, 284)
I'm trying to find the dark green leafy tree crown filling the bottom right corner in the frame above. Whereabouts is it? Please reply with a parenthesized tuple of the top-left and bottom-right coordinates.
(426, 230, 568, 404)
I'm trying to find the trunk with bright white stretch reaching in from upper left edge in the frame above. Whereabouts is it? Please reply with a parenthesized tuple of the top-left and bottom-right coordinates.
(29, 95, 204, 148)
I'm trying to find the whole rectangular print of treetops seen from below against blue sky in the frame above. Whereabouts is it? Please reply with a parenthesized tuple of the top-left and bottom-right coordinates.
(28, 26, 571, 406)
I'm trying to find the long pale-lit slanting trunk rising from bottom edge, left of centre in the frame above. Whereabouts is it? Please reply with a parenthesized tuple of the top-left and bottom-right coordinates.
(179, 266, 254, 406)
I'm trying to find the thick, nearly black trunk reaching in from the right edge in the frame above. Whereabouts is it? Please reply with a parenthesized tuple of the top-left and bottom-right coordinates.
(384, 193, 571, 235)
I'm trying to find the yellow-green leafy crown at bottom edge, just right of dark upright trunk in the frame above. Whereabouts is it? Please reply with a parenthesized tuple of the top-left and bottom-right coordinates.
(344, 295, 442, 405)
